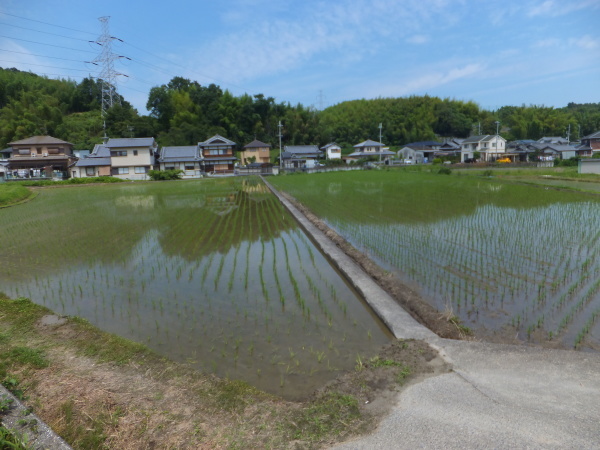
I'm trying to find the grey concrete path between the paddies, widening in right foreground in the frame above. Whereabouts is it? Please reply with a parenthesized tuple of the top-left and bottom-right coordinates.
(267, 180, 600, 449)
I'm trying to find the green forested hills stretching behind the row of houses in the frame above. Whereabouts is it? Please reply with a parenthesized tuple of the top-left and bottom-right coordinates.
(0, 69, 600, 149)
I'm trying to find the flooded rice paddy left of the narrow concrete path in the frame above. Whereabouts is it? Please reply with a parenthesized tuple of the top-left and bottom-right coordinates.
(0, 178, 391, 398)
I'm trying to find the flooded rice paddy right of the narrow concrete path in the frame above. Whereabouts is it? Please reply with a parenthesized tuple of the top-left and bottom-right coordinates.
(273, 171, 600, 350)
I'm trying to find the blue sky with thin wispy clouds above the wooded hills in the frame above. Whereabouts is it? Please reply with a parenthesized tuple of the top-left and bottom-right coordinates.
(0, 0, 600, 114)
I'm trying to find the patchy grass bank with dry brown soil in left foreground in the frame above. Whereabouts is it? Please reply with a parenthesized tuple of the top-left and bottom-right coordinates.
(0, 296, 446, 449)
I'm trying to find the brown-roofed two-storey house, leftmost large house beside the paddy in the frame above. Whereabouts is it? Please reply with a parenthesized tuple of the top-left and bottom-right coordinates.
(7, 136, 76, 178)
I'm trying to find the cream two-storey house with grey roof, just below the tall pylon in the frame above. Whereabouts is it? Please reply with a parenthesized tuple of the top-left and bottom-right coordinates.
(104, 137, 158, 180)
